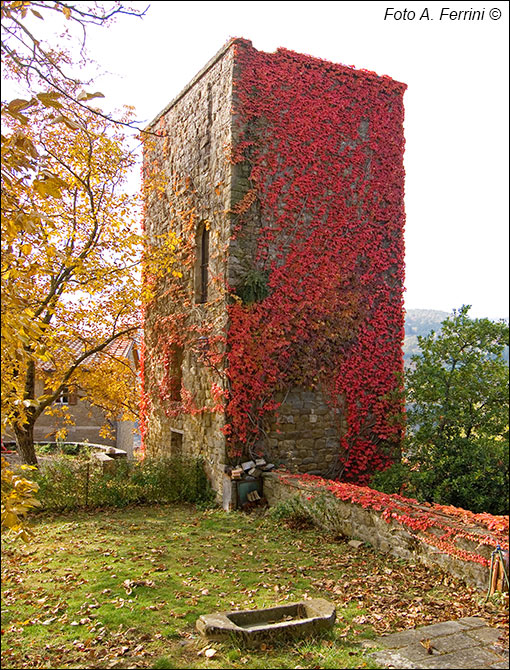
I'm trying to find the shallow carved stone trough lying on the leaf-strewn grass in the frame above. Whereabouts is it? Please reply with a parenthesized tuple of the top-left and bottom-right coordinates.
(196, 598, 336, 644)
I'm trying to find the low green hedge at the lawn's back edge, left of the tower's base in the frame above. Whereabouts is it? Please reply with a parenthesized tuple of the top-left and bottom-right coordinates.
(34, 456, 214, 511)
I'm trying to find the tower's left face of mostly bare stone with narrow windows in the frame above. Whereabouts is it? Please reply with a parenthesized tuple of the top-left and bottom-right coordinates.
(143, 40, 232, 488)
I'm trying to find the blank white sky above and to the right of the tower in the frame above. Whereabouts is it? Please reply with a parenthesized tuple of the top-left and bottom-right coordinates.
(6, 0, 510, 318)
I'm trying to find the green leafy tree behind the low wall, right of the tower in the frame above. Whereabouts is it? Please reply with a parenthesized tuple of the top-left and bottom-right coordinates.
(375, 305, 509, 514)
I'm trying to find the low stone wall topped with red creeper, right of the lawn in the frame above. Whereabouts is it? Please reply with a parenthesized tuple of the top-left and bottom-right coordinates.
(264, 471, 508, 590)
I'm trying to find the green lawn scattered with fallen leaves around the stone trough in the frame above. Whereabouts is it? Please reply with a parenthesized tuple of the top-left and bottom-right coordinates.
(2, 505, 502, 668)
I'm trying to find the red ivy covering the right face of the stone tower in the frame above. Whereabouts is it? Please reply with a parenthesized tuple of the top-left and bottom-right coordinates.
(227, 43, 405, 482)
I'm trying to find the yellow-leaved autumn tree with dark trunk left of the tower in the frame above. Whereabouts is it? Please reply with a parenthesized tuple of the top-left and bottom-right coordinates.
(2, 94, 141, 464)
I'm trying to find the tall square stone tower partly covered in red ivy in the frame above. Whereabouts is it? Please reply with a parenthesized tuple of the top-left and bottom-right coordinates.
(141, 39, 405, 498)
